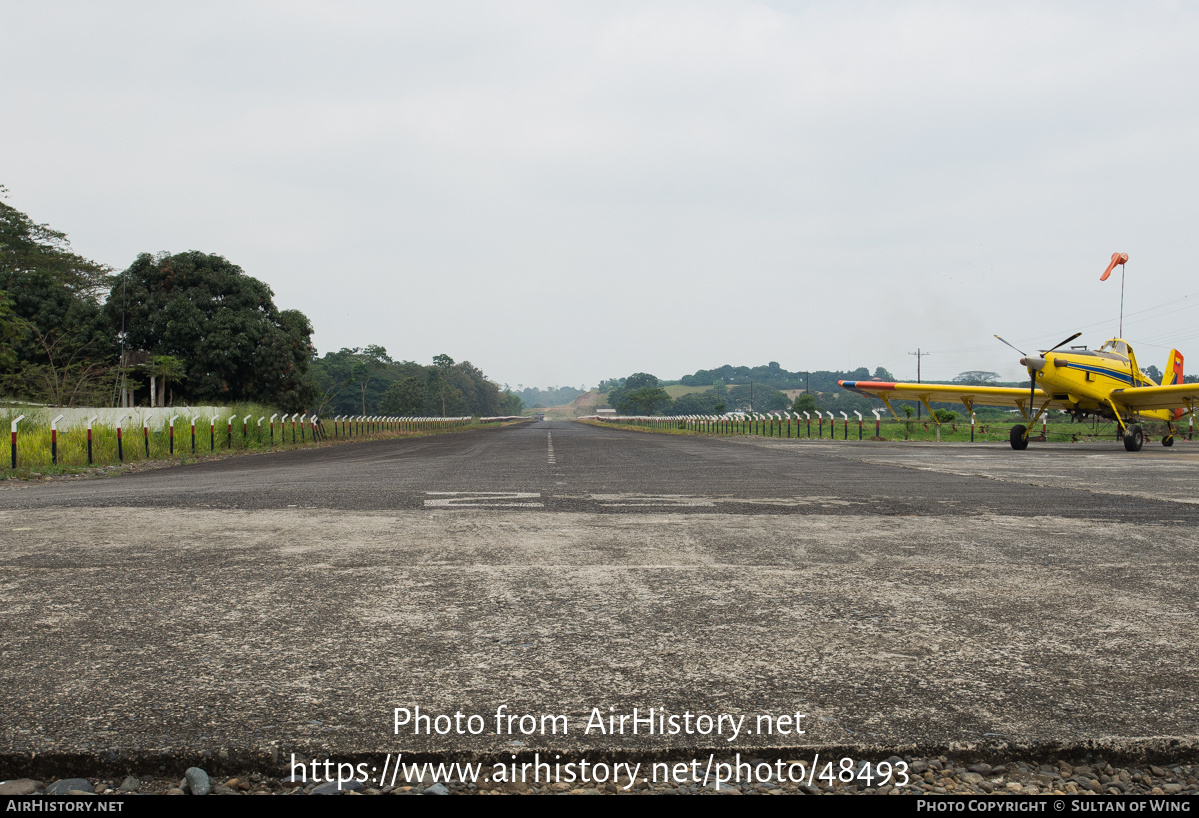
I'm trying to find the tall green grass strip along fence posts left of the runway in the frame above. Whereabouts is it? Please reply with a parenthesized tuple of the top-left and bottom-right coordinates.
(0, 403, 498, 480)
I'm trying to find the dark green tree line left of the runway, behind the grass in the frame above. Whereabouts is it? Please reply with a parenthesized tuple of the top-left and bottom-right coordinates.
(0, 186, 519, 416)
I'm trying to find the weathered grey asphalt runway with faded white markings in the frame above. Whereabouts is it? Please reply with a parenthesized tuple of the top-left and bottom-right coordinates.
(0, 422, 1199, 766)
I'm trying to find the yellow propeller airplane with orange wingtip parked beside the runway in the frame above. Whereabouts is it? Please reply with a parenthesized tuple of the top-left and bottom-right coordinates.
(838, 333, 1199, 452)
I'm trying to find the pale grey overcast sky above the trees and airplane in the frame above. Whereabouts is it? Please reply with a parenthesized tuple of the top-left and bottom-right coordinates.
(0, 0, 1199, 386)
